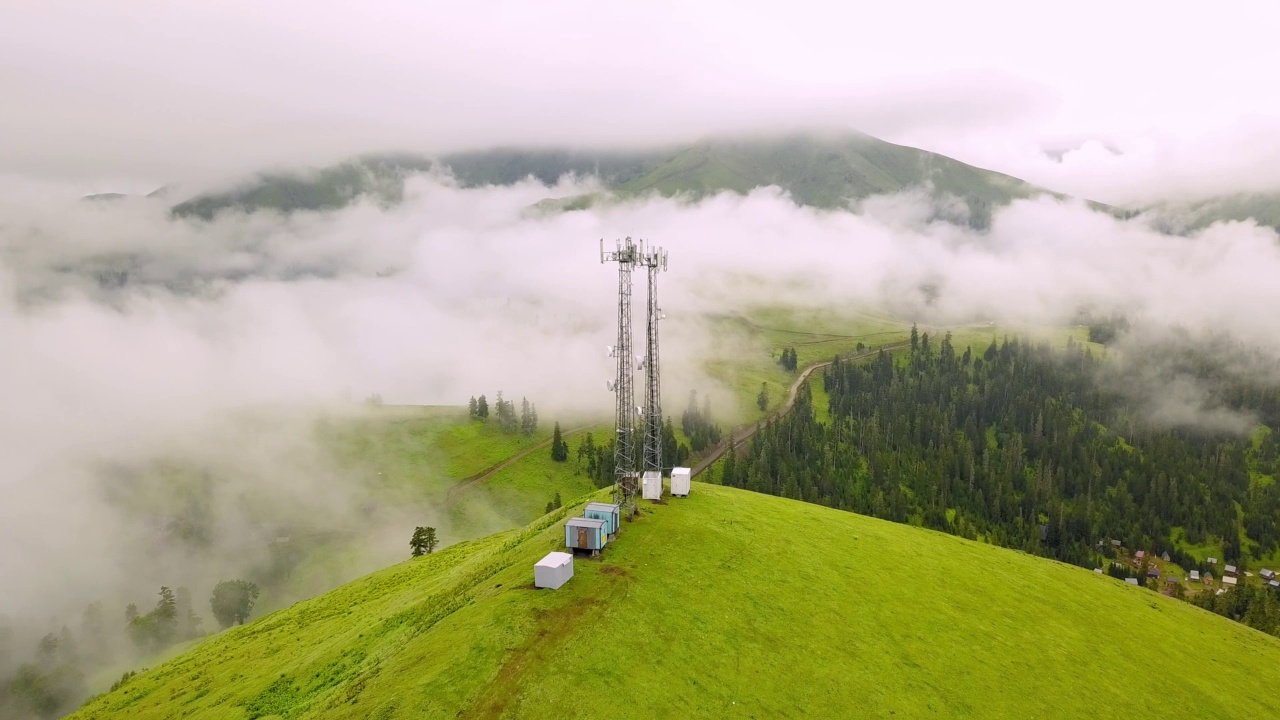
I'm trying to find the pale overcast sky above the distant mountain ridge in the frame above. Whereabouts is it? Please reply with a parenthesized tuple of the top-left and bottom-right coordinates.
(0, 0, 1280, 201)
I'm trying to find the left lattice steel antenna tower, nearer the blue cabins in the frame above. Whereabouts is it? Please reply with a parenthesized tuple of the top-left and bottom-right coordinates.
(600, 237, 643, 514)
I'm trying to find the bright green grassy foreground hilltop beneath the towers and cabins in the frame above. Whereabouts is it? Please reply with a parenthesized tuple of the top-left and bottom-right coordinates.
(67, 484, 1280, 720)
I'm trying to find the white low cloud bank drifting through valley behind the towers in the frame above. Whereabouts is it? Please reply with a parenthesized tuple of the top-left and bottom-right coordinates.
(0, 177, 1280, 655)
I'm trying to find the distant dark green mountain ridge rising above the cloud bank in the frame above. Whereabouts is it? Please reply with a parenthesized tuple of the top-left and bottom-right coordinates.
(165, 133, 1075, 224)
